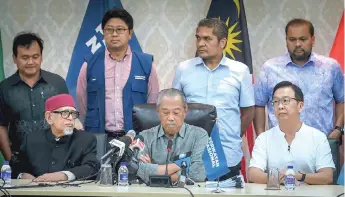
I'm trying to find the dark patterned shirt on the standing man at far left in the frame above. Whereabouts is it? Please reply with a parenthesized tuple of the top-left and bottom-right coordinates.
(0, 70, 68, 151)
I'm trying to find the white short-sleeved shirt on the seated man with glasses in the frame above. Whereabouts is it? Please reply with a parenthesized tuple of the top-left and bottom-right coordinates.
(249, 123, 335, 173)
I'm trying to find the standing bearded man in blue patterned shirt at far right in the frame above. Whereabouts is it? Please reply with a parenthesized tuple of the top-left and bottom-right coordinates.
(254, 19, 344, 138)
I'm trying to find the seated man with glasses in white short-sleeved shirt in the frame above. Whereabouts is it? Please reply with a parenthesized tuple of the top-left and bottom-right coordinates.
(248, 81, 335, 184)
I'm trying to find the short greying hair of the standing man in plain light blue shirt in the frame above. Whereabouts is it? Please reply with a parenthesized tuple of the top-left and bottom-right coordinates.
(198, 18, 228, 41)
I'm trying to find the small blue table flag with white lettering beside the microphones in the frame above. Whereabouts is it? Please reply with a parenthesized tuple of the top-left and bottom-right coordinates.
(202, 124, 230, 181)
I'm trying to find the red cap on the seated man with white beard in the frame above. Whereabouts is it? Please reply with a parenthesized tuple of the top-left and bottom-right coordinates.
(46, 94, 75, 111)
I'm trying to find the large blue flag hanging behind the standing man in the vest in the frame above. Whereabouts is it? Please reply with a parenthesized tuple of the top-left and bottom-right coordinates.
(66, 0, 142, 100)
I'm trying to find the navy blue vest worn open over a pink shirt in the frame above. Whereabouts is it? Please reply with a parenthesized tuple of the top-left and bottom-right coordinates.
(84, 50, 153, 133)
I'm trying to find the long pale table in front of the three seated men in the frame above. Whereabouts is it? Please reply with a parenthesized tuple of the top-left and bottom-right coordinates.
(2, 180, 344, 197)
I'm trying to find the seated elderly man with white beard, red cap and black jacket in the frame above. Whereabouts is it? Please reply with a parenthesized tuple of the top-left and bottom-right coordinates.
(11, 94, 100, 182)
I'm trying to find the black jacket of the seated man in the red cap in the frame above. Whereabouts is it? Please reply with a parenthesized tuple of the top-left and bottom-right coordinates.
(11, 129, 100, 179)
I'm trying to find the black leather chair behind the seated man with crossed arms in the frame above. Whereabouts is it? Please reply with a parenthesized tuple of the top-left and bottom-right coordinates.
(133, 103, 217, 135)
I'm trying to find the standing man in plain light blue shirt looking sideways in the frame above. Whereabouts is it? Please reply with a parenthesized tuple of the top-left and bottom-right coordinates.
(173, 18, 255, 180)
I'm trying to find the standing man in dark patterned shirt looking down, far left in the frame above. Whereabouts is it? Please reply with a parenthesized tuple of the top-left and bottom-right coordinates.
(0, 33, 68, 160)
